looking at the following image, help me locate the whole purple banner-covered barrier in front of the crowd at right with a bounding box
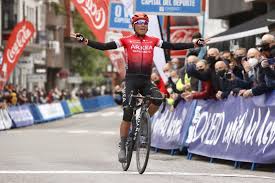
[151,93,275,169]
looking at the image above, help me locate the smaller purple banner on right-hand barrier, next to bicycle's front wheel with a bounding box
[151,102,195,149]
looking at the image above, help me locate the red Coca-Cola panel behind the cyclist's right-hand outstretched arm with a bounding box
[170,26,199,58]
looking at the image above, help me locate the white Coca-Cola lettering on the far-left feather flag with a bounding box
[7,26,32,63]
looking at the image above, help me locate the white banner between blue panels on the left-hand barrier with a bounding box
[37,103,65,121]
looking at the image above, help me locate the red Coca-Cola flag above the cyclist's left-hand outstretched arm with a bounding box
[72,0,110,42]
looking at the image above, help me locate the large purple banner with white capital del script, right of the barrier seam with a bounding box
[187,94,275,163]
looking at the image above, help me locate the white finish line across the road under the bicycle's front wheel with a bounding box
[0,170,275,180]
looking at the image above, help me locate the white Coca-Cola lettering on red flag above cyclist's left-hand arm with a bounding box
[76,0,107,30]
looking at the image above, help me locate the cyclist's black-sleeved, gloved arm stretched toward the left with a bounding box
[71,33,118,50]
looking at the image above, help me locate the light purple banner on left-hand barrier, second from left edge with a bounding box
[8,105,34,127]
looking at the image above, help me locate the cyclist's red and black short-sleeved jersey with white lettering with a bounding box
[116,35,163,76]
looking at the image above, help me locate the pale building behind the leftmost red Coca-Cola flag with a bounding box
[1,0,46,90]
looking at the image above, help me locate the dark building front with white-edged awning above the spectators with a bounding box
[209,0,275,50]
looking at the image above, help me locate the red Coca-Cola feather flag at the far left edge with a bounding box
[0,20,35,90]
